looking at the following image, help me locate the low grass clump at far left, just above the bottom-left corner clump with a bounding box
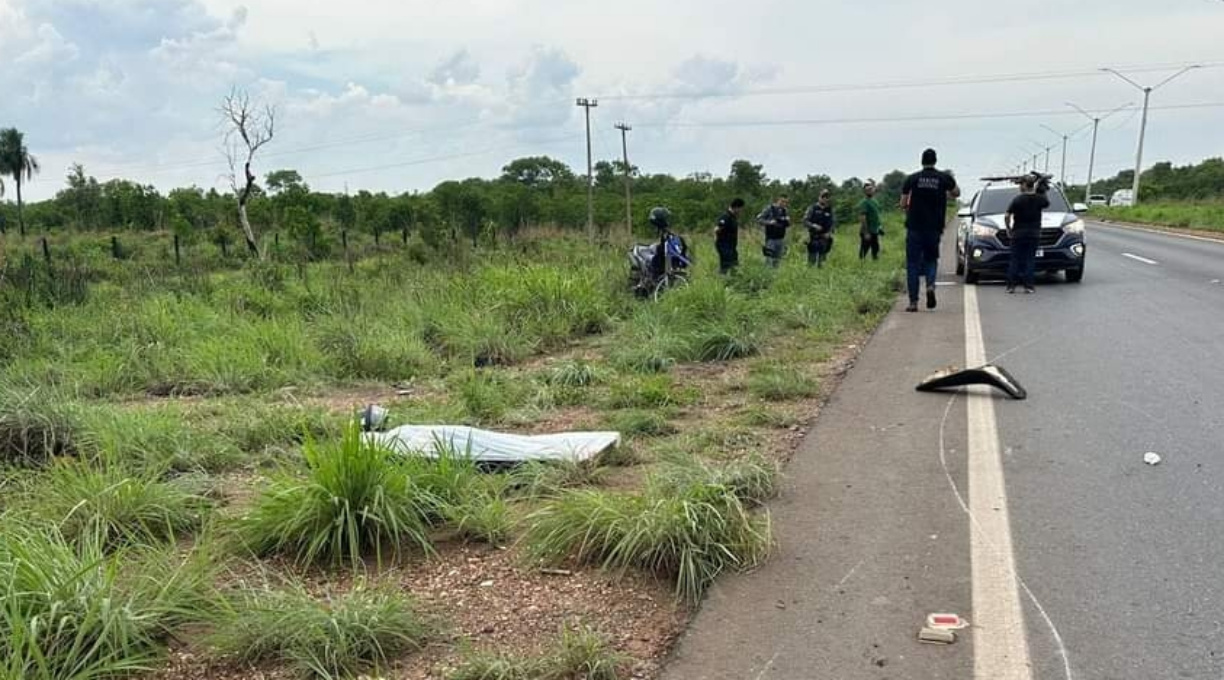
[24,461,208,545]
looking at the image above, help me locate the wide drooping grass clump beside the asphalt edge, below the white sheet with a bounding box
[525,482,770,603]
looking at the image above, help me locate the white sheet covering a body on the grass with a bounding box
[364,426,621,464]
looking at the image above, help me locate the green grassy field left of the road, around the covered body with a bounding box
[0,220,901,680]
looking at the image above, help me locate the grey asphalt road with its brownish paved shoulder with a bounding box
[665,225,1224,680]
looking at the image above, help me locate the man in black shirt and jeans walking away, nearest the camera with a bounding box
[901,149,961,312]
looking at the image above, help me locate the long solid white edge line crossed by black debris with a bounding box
[965,286,1033,680]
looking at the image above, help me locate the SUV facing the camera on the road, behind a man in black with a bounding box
[956,181,1088,284]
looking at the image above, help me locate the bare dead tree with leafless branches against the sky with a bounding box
[219,87,277,259]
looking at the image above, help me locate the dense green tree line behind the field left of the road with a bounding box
[0,151,920,249]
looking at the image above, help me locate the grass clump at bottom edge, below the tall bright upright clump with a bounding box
[212,585,437,680]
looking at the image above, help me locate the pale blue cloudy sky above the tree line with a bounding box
[0,0,1224,201]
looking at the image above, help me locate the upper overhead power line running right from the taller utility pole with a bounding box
[601,61,1224,100]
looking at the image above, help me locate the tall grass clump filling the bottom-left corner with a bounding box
[0,525,212,680]
